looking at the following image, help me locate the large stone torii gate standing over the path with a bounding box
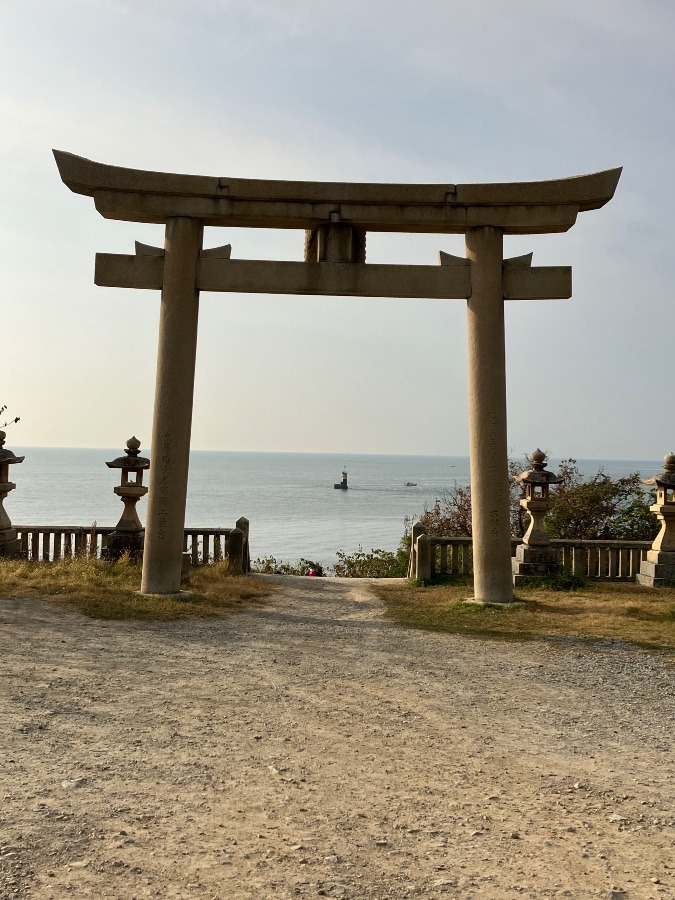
[54,150,621,603]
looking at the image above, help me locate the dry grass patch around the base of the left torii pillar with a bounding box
[0,557,277,622]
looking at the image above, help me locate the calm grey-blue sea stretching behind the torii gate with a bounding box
[5,445,661,566]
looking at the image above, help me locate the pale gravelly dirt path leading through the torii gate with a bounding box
[0,577,675,900]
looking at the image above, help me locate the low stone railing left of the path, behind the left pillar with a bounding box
[13,517,251,572]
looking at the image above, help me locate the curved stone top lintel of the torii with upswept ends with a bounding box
[54,150,621,234]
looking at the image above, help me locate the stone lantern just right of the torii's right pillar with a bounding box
[512,448,562,584]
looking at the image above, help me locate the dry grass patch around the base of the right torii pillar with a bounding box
[373,583,675,652]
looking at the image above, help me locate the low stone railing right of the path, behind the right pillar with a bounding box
[408,528,651,581]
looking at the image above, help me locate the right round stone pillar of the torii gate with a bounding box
[466,227,513,603]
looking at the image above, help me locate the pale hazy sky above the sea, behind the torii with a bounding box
[0,0,675,458]
